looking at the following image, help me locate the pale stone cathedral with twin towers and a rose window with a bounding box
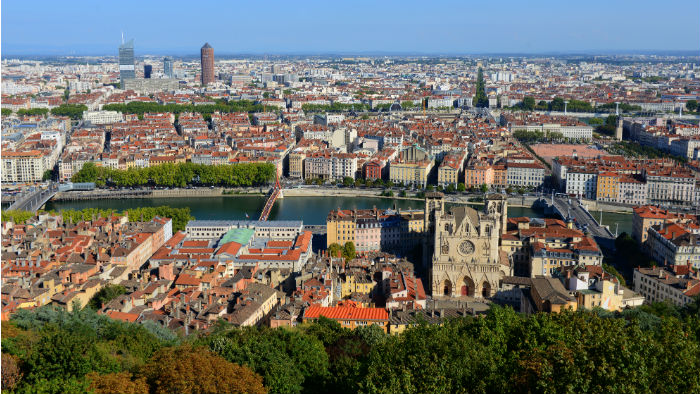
[425,193,512,299]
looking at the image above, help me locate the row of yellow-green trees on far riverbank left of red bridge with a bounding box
[71,162,276,187]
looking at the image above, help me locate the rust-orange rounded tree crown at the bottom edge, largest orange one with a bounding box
[141,345,267,394]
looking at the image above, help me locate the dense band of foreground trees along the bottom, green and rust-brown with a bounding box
[2,301,700,394]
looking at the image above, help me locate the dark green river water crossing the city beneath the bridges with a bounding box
[45,196,632,234]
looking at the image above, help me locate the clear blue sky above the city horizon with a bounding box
[0,0,700,56]
